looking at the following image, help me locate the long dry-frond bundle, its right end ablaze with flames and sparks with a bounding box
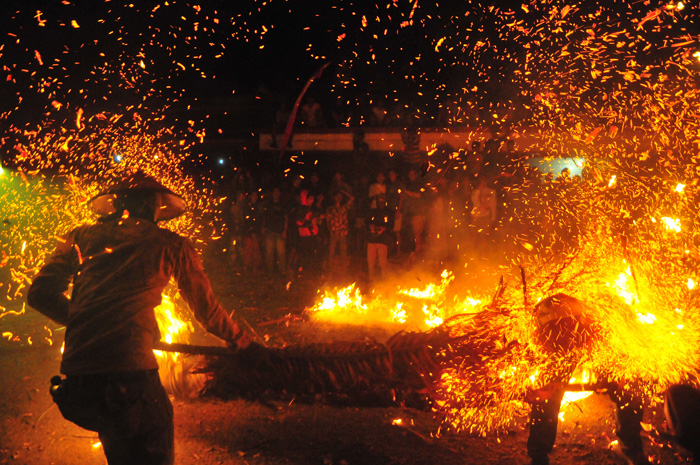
[187,238,698,433]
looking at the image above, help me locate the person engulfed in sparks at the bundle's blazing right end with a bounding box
[527,294,649,465]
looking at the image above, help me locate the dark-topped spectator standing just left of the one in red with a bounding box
[262,187,289,274]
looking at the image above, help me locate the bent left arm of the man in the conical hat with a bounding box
[27,234,77,325]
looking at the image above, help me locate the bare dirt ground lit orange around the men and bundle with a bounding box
[0,258,690,465]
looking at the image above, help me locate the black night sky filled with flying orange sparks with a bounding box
[0,0,700,161]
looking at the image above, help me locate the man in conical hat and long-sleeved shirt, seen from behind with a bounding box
[28,173,251,465]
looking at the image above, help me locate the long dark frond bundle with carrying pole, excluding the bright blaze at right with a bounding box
[152,296,604,418]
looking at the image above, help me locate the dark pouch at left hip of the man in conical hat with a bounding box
[49,376,107,431]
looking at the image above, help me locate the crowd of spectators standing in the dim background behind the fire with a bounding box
[223,136,579,283]
